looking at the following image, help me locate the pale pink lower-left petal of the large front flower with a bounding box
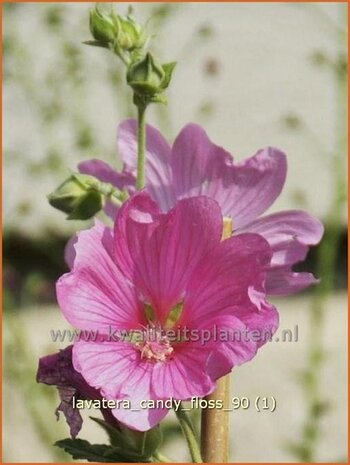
[73,342,168,431]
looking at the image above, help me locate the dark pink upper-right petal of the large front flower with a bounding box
[181,233,272,327]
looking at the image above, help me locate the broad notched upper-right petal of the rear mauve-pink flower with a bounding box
[171,124,287,229]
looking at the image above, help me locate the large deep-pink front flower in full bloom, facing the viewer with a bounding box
[57,192,278,430]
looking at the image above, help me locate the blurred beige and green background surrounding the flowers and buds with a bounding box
[3,2,347,463]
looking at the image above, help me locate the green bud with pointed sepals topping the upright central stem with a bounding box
[127,53,175,97]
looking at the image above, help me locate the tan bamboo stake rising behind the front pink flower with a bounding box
[201,218,233,463]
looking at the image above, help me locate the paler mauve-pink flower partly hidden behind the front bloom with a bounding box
[79,120,323,295]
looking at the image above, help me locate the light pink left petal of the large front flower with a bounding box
[56,222,145,333]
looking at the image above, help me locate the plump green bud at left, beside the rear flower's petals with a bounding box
[48,174,104,220]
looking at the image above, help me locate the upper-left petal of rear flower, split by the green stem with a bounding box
[117,119,175,211]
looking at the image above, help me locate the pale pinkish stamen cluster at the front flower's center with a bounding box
[136,328,174,362]
